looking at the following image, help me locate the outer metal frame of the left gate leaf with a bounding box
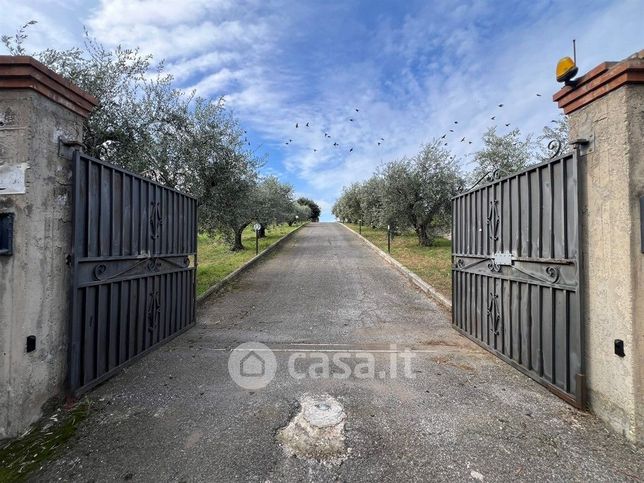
[64,149,199,398]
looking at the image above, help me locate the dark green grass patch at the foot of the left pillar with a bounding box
[0,400,90,482]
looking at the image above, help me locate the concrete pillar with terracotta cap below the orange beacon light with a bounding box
[553,51,644,442]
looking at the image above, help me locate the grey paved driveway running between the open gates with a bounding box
[35,224,644,481]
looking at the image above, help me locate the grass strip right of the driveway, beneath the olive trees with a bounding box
[345,223,452,298]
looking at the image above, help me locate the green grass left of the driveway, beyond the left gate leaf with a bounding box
[197,225,299,296]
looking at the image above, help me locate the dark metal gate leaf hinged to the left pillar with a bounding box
[68,151,197,394]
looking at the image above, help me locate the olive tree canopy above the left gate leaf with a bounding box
[1,21,320,250]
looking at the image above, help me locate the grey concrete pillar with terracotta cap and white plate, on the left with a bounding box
[0,56,96,439]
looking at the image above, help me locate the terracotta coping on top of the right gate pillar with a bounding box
[552,50,644,114]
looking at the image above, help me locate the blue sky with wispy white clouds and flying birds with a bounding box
[0,0,644,220]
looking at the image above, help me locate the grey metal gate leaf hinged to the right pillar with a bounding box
[452,153,585,407]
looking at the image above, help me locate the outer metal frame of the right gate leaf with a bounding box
[451,147,588,411]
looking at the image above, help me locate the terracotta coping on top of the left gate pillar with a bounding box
[0,55,98,118]
